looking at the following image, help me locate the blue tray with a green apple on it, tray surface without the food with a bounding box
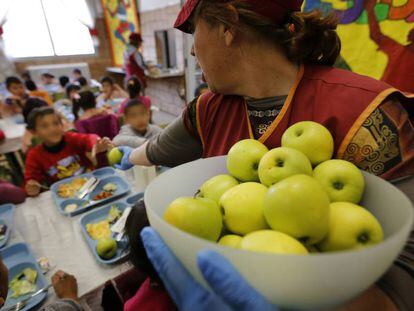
[79,192,144,265]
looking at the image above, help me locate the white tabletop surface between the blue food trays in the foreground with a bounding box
[8,169,149,310]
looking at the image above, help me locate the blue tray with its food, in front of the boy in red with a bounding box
[51,167,130,216]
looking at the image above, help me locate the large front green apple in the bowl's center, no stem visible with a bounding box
[264,175,329,245]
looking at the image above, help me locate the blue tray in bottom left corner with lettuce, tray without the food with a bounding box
[0,243,48,311]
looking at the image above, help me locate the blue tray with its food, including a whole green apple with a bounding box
[79,193,144,264]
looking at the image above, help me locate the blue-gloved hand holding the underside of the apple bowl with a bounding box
[141,227,278,311]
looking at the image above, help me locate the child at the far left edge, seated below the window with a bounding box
[0,77,29,118]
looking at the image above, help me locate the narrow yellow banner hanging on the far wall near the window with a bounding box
[101,0,140,66]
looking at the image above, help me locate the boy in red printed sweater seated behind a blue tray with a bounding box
[25,107,107,196]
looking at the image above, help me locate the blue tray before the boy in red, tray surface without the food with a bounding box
[50,167,130,217]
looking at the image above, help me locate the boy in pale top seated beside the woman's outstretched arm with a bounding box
[113,99,162,148]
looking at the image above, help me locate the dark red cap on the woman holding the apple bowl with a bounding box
[174,0,304,33]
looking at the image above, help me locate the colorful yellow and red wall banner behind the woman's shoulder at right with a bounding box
[304,0,414,87]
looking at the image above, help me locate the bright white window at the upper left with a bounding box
[1,0,95,58]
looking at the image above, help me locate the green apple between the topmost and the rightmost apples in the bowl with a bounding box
[313,160,365,203]
